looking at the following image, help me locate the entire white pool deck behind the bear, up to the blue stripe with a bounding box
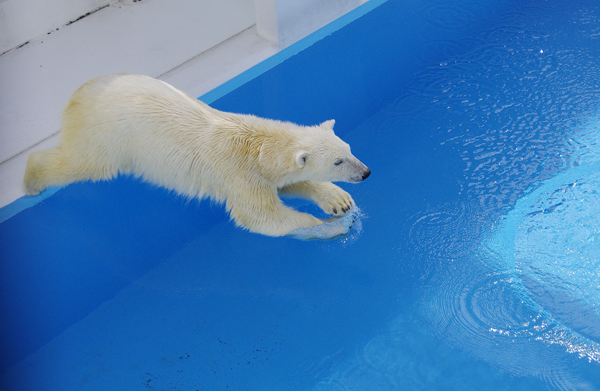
[0,0,365,207]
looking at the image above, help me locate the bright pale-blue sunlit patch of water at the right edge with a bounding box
[490,124,600,361]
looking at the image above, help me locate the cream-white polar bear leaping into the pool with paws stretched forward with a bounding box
[24,74,371,236]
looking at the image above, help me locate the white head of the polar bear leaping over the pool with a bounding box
[294,120,371,183]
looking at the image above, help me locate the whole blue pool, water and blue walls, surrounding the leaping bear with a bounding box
[0,0,600,391]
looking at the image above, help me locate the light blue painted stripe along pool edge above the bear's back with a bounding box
[198,0,387,104]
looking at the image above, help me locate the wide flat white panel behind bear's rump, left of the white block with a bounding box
[0,0,255,162]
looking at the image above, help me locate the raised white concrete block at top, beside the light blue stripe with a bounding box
[254,0,366,49]
